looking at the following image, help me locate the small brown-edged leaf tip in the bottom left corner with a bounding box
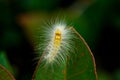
[0,64,15,80]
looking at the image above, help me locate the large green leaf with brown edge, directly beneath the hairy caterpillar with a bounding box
[32,28,97,80]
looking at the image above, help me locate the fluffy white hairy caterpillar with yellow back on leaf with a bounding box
[38,22,75,65]
